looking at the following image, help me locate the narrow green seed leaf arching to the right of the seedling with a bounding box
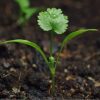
[61,29,97,48]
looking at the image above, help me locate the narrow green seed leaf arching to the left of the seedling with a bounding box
[0,39,49,65]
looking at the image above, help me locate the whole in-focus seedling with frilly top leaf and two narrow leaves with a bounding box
[0,8,97,95]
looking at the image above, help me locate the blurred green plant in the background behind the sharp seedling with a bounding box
[15,0,38,25]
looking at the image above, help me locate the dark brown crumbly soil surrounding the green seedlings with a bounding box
[0,0,100,100]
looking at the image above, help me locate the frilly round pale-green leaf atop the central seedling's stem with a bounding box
[38,8,68,34]
